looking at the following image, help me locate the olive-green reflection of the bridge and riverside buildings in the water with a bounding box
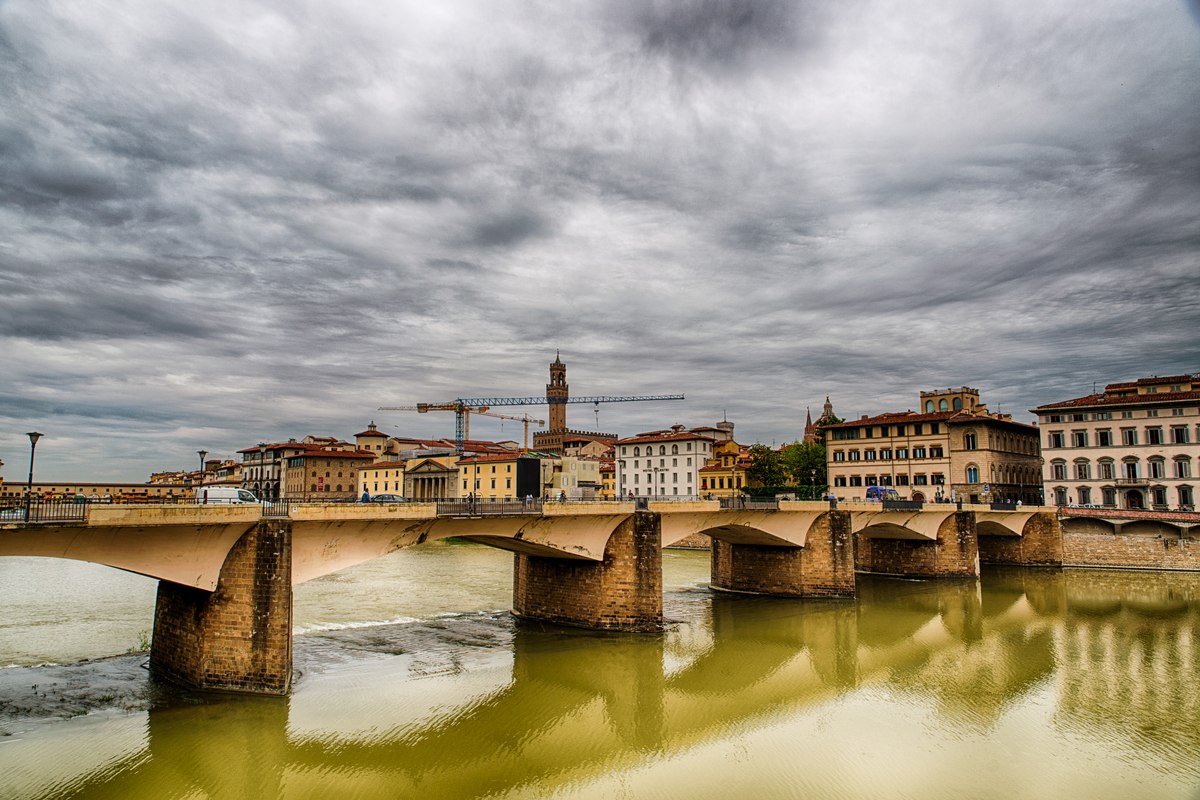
[42,570,1200,798]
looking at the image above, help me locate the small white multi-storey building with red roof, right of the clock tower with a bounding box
[616,425,713,498]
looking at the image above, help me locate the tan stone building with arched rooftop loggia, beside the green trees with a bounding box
[823,386,1042,505]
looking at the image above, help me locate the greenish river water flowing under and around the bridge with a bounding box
[0,542,1200,800]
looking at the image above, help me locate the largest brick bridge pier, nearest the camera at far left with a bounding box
[150,521,292,694]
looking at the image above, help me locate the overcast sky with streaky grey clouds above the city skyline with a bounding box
[0,0,1200,482]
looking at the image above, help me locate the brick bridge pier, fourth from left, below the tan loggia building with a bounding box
[857,511,979,578]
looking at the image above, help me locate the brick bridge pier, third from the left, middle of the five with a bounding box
[710,511,854,597]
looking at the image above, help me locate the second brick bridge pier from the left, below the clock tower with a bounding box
[512,511,662,631]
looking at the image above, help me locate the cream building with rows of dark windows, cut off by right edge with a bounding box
[1033,374,1200,510]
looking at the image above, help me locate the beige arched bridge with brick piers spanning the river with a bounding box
[0,501,1061,693]
